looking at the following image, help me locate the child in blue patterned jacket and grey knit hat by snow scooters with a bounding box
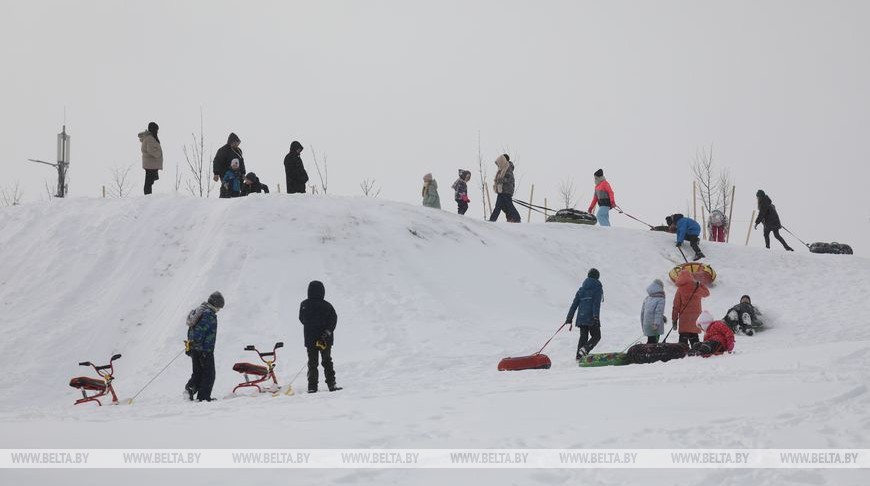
[184,292,225,402]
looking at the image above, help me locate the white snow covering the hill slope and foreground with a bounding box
[0,195,870,485]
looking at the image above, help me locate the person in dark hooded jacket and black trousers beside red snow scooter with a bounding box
[299,280,341,393]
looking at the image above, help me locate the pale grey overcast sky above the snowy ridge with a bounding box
[0,0,870,255]
